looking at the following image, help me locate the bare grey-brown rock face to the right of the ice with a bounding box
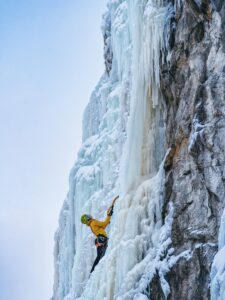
[156,0,225,300]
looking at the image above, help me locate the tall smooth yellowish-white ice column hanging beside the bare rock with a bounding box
[120,0,166,195]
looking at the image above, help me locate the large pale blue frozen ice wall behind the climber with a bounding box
[53,0,170,300]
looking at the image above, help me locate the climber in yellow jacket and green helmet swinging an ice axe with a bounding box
[81,196,119,273]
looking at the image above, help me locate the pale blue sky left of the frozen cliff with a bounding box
[0,0,106,300]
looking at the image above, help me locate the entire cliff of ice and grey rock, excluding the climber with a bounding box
[53,0,225,300]
